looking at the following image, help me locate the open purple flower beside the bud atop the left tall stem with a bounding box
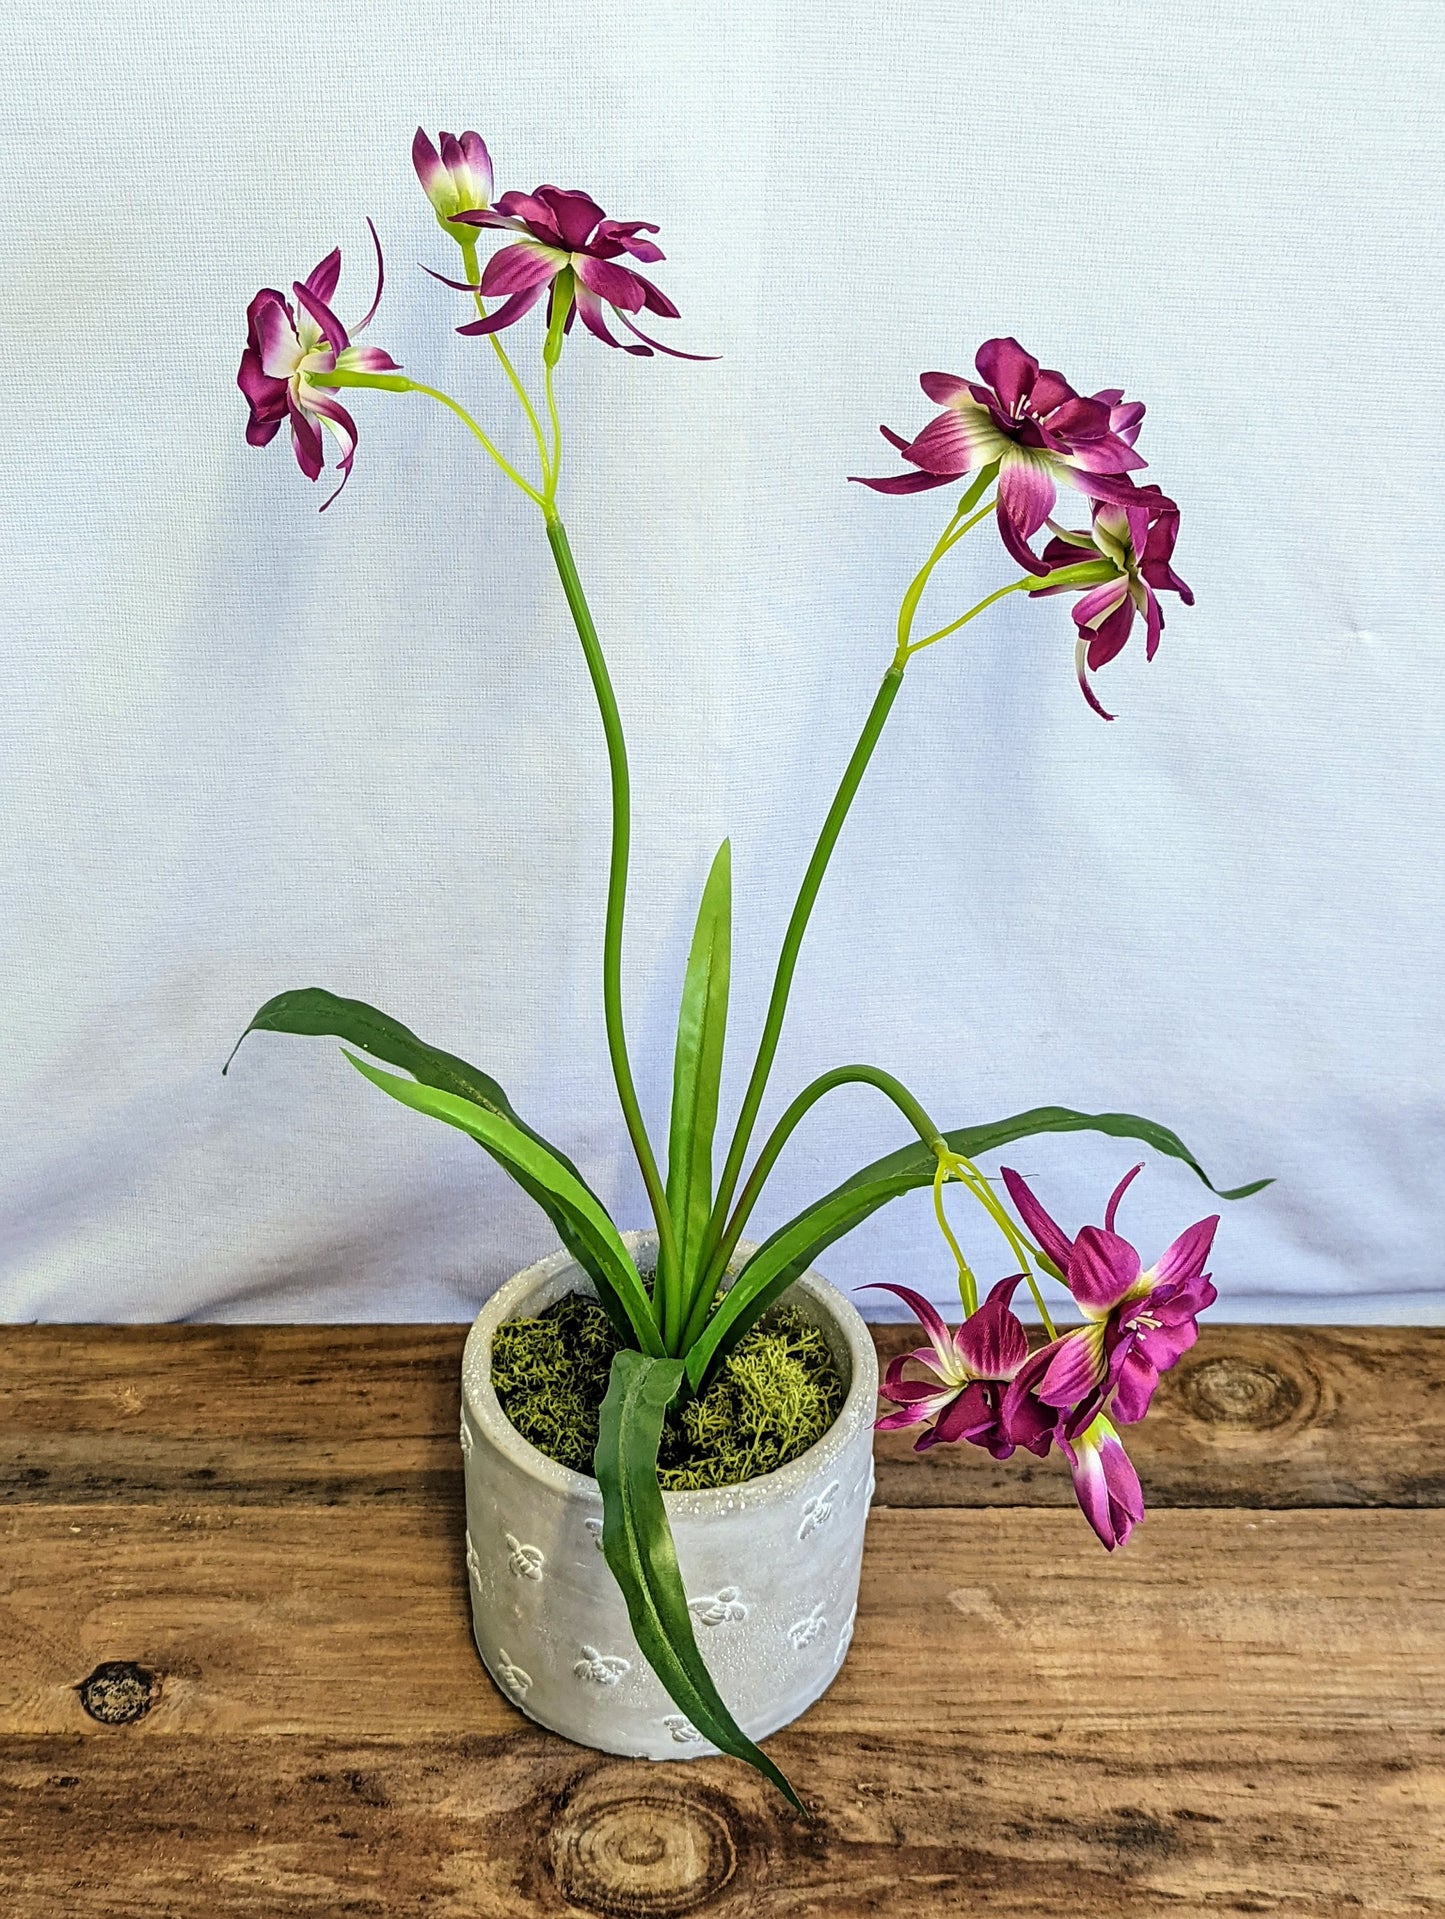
[434,186,708,359]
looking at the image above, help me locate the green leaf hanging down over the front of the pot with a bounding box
[595,1353,808,1817]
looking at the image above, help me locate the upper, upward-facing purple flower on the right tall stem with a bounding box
[852,340,1148,574]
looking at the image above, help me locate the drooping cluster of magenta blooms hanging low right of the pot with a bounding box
[877,1167,1219,1551]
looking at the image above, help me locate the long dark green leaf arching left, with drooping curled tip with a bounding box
[221,986,629,1339]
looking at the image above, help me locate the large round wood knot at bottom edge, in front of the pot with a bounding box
[551,1794,737,1919]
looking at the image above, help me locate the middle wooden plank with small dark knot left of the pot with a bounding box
[0,1504,1445,1752]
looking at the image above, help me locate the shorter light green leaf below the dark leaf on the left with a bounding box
[342,1048,662,1355]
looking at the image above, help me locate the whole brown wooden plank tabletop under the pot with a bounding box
[0,1326,1445,1919]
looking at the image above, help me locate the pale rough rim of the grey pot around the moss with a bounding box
[462,1232,879,1522]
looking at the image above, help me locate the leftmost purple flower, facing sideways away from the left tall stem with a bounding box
[236,221,397,512]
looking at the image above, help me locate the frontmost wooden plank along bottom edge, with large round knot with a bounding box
[0,1723,1445,1919]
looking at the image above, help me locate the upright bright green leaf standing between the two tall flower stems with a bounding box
[668,841,733,1290]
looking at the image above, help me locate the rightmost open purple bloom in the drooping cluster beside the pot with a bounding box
[1002,1167,1219,1447]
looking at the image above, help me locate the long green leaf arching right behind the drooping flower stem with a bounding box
[687,1105,1270,1389]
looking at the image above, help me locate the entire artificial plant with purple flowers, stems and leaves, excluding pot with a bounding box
[228,129,1267,1798]
